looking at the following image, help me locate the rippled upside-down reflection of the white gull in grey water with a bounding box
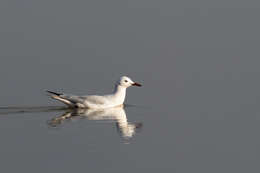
[48,107,142,139]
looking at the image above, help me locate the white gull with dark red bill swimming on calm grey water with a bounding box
[47,76,142,109]
